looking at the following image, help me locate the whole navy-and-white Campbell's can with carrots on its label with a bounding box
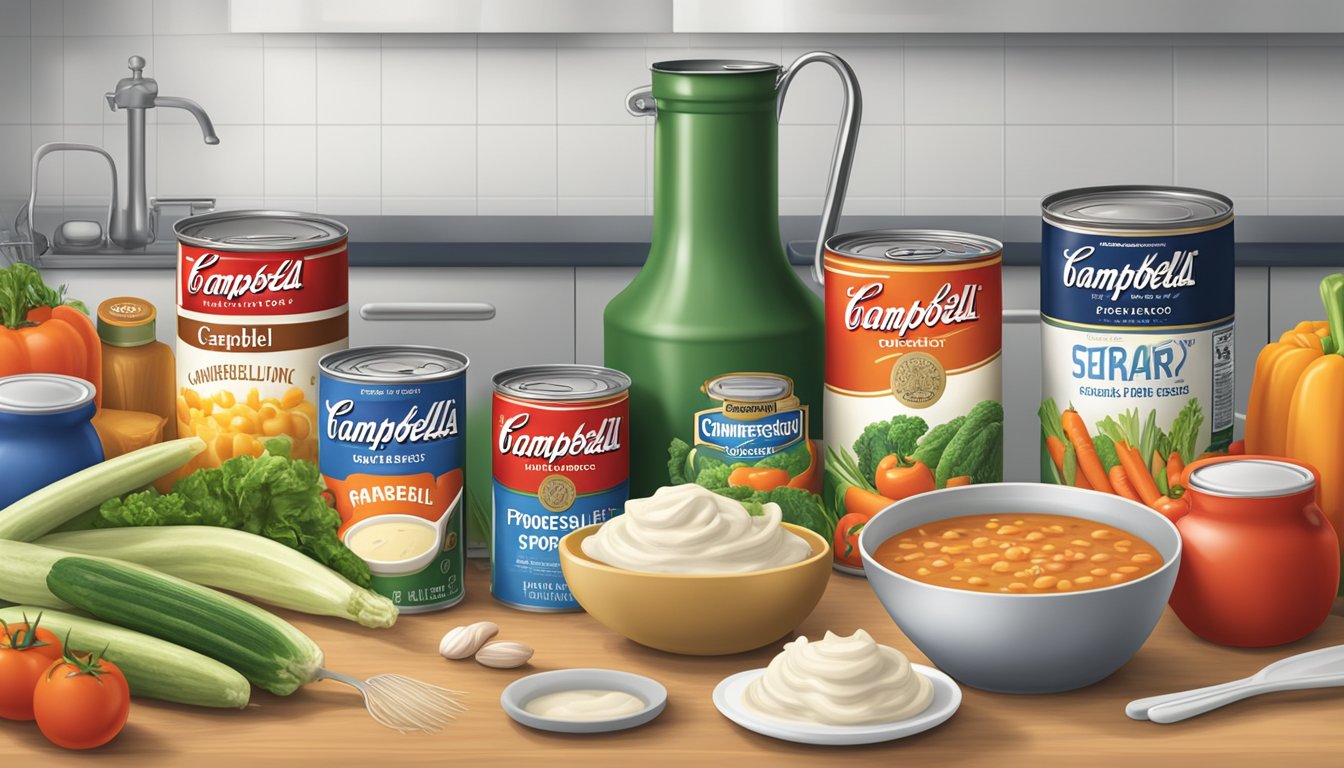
[1040,187,1235,492]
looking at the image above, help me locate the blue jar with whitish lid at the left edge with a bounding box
[0,374,102,508]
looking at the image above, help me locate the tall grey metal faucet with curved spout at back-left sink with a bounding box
[106,56,219,249]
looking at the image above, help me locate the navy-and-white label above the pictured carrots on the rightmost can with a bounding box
[1040,222,1235,482]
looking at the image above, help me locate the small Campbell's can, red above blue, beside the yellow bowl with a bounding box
[491,364,630,611]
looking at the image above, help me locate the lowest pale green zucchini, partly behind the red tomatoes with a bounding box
[0,605,251,709]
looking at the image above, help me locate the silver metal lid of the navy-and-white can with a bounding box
[1040,186,1232,231]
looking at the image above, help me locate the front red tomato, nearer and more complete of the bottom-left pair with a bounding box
[32,654,130,749]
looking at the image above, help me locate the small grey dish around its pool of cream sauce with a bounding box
[500,668,668,733]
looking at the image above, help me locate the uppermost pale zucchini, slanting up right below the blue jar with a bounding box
[0,437,206,541]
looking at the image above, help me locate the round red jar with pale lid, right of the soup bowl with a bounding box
[1171,456,1340,647]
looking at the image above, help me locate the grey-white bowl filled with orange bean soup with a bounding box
[859,483,1181,693]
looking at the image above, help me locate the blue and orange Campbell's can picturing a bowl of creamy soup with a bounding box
[320,346,468,613]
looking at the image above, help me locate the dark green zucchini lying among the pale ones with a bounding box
[46,554,323,695]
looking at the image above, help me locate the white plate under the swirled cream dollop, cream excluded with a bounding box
[714,664,961,746]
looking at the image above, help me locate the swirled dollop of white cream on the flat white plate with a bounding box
[743,629,933,725]
